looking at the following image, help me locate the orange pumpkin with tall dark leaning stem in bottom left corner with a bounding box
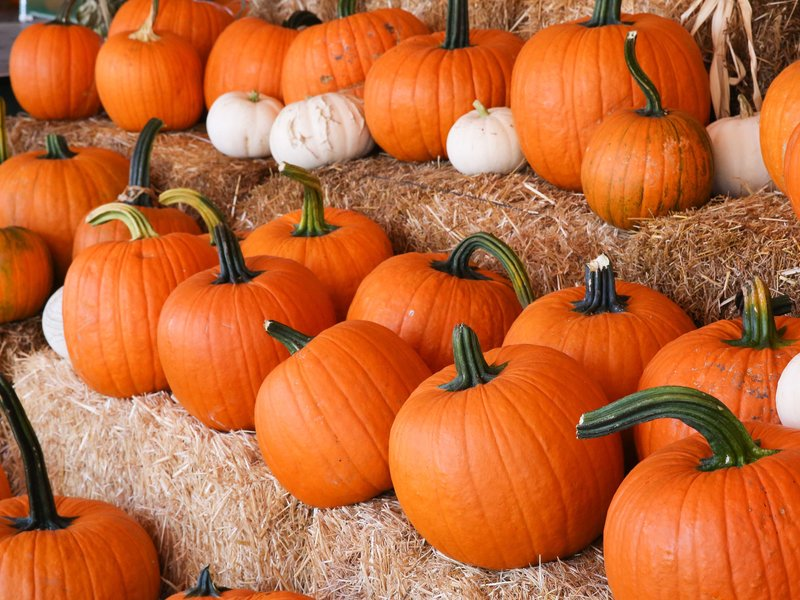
[0,377,161,600]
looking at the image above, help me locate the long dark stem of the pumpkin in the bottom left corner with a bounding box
[0,376,75,531]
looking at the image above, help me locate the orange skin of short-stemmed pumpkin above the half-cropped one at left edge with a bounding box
[0,136,128,281]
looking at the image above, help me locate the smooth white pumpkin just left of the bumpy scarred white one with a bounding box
[206,92,283,158]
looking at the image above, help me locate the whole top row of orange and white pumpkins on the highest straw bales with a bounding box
[10,0,800,228]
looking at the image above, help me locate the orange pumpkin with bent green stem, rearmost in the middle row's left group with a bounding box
[242,163,392,320]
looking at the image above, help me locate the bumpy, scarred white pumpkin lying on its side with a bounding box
[269,93,375,169]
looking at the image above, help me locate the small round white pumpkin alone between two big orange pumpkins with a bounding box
[447,100,525,175]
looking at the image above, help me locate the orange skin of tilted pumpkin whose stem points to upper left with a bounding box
[256,321,431,508]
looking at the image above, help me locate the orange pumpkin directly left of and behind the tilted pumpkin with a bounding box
[158,225,336,431]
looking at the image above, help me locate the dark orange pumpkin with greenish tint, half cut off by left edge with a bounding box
[0,227,53,324]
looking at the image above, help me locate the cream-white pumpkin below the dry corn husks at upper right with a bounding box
[706,95,770,198]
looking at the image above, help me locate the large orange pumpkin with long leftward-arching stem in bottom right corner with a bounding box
[578,387,800,600]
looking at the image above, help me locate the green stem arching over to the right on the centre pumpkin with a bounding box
[431,231,533,308]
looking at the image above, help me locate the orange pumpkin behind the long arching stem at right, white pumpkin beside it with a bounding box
[634,278,800,458]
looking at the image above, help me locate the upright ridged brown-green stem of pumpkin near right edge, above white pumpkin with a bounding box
[725,277,796,350]
